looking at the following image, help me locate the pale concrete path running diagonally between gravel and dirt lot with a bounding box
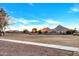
[0,39,79,52]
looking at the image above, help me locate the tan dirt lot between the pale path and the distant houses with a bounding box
[0,33,79,47]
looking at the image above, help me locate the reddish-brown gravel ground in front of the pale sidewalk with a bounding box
[0,41,79,56]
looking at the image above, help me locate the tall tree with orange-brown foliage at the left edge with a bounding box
[0,8,9,35]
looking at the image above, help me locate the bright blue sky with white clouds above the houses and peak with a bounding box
[0,3,79,31]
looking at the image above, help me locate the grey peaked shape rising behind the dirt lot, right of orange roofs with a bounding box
[50,25,69,34]
